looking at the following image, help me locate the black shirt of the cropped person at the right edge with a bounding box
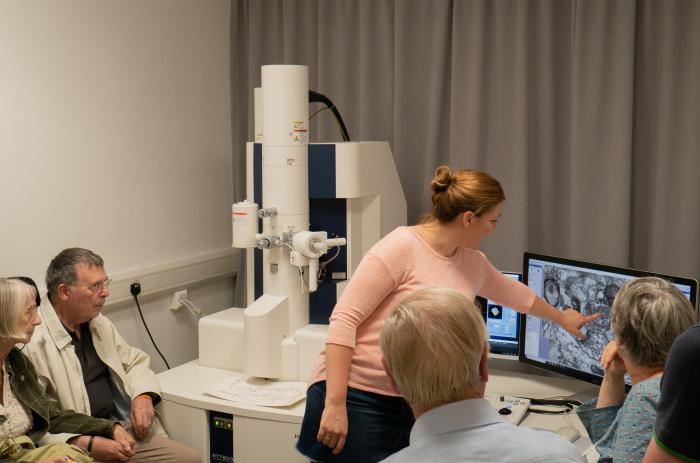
[654,324,700,461]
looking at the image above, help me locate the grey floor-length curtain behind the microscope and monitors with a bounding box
[231,0,700,278]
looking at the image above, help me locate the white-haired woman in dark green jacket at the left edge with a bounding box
[0,278,133,463]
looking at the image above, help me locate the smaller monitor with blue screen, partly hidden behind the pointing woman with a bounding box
[477,272,522,357]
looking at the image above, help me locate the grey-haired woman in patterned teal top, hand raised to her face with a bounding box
[577,277,695,463]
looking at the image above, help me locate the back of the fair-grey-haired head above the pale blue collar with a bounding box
[380,289,487,408]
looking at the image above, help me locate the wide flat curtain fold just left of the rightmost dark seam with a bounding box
[562,0,635,263]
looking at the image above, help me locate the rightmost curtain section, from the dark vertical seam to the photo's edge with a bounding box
[630,0,700,279]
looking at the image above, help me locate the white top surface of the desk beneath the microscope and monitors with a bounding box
[158,358,597,452]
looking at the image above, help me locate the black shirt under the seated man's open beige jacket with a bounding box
[66,322,114,418]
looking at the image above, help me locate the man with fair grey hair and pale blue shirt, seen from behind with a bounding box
[380,289,584,463]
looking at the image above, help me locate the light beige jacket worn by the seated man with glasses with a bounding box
[24,300,165,435]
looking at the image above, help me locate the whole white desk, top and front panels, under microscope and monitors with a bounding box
[158,358,598,463]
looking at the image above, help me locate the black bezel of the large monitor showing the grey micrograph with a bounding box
[518,252,698,385]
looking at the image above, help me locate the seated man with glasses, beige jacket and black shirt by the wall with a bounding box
[25,248,199,463]
